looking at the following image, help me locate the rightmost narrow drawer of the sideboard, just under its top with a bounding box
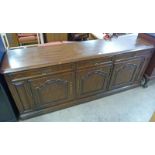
[114,50,152,61]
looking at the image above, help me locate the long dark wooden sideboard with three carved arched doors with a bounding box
[1,35,154,119]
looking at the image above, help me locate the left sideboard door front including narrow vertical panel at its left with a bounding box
[13,72,74,113]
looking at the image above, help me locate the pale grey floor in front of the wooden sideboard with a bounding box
[25,81,155,122]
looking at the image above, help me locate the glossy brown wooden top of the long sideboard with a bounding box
[1,35,154,74]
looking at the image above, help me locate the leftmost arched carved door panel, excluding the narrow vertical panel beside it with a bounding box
[28,72,74,107]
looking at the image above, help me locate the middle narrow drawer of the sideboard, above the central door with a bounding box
[77,57,112,69]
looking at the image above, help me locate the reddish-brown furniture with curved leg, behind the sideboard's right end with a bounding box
[139,33,155,88]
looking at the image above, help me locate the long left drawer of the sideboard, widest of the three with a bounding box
[9,63,74,81]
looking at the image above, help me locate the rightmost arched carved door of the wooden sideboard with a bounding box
[110,57,145,89]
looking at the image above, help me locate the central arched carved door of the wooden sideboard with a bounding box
[77,64,112,97]
